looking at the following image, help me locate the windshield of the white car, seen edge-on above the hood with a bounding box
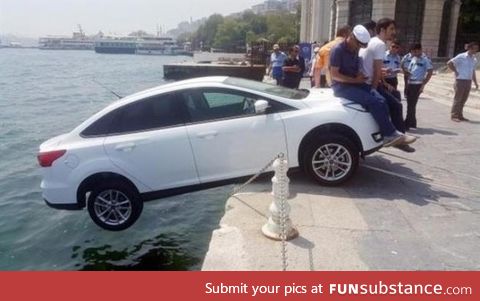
[224,77,310,99]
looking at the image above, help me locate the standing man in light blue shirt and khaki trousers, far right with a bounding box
[447,42,478,122]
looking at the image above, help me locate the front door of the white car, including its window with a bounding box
[179,88,287,183]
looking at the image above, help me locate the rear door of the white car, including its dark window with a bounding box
[104,94,199,191]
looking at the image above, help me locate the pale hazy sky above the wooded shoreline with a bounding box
[0,0,263,38]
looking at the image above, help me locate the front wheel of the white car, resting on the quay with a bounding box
[303,134,359,186]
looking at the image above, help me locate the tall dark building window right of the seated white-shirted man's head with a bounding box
[395,0,425,49]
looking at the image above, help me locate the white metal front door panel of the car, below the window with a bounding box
[187,114,287,183]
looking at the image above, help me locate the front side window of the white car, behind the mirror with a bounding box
[183,88,257,122]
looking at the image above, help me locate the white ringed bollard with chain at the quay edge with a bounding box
[262,154,298,240]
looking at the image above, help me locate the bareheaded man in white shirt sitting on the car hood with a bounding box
[359,18,416,152]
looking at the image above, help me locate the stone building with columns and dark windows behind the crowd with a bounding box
[300,0,462,58]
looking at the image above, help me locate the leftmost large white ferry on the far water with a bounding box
[38,25,94,50]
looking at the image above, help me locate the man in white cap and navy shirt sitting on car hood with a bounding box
[330,25,407,146]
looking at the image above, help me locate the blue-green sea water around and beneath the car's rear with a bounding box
[0,49,232,270]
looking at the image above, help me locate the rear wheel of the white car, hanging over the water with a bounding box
[87,181,143,231]
